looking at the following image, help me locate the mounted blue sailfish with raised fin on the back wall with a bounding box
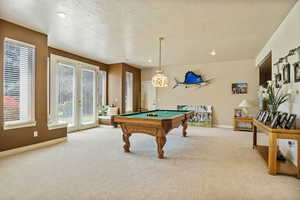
[173,71,211,89]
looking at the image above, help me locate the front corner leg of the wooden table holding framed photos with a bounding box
[268,133,277,175]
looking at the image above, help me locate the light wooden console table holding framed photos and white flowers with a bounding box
[253,119,300,179]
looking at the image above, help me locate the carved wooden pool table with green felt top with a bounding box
[113,110,194,159]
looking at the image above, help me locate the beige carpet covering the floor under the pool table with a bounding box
[0,127,300,200]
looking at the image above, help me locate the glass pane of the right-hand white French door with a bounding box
[80,69,96,125]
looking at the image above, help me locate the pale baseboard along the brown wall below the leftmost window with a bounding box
[0,137,67,158]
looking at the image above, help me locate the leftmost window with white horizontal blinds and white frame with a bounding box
[3,38,35,126]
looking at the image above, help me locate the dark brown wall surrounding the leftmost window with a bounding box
[0,19,67,151]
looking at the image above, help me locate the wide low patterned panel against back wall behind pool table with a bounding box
[177,105,213,127]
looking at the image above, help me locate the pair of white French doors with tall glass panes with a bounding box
[51,56,98,131]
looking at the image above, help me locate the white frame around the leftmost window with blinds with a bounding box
[2,37,36,130]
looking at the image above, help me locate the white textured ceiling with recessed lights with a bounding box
[0,0,297,67]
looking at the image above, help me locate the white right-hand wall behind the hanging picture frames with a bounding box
[256,1,300,166]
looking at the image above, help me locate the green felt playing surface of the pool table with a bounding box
[120,110,189,119]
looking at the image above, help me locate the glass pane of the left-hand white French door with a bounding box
[56,64,75,127]
